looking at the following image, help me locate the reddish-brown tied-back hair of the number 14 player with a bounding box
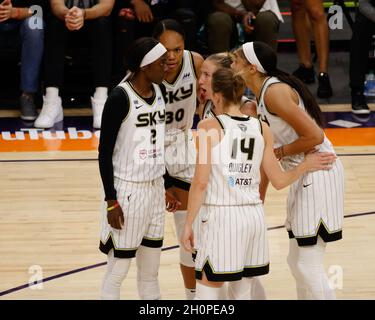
[211,68,246,104]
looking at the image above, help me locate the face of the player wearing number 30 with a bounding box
[159,30,185,73]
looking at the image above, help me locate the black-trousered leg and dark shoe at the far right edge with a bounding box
[350,0,375,114]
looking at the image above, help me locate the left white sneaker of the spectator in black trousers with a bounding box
[34,96,64,128]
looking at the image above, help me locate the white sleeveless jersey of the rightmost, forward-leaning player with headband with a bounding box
[257,77,335,170]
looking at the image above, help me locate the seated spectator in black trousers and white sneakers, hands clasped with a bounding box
[34,0,115,128]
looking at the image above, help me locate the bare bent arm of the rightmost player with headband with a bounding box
[264,83,324,158]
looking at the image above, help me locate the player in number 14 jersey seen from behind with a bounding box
[181,69,335,300]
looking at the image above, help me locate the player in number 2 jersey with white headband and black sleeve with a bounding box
[99,38,166,299]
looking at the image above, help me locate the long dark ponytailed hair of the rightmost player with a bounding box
[241,41,322,127]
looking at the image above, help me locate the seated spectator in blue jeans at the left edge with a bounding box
[0,0,44,120]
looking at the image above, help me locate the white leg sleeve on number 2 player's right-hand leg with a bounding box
[136,246,161,300]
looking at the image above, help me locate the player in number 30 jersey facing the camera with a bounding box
[153,19,203,300]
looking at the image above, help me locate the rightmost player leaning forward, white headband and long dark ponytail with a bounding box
[233,42,344,299]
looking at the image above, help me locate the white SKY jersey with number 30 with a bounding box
[163,50,197,141]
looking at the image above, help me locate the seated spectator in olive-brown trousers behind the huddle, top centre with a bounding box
[207,0,283,54]
